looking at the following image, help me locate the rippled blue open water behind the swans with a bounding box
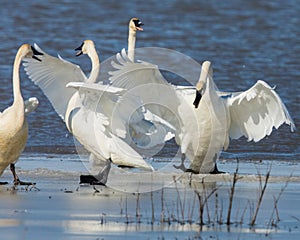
[0,0,300,160]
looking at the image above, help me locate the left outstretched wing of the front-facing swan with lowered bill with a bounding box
[109,49,180,128]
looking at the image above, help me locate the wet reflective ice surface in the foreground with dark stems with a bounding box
[0,154,300,239]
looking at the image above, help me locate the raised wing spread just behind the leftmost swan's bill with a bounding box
[23,44,86,119]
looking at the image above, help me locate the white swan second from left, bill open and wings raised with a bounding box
[23,40,153,184]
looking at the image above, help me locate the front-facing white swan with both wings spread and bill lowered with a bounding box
[109,50,295,173]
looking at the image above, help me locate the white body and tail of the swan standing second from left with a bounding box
[67,82,153,170]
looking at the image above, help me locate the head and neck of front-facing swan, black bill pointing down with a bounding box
[193,61,212,108]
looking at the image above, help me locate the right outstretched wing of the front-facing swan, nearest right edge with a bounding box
[227,80,295,142]
